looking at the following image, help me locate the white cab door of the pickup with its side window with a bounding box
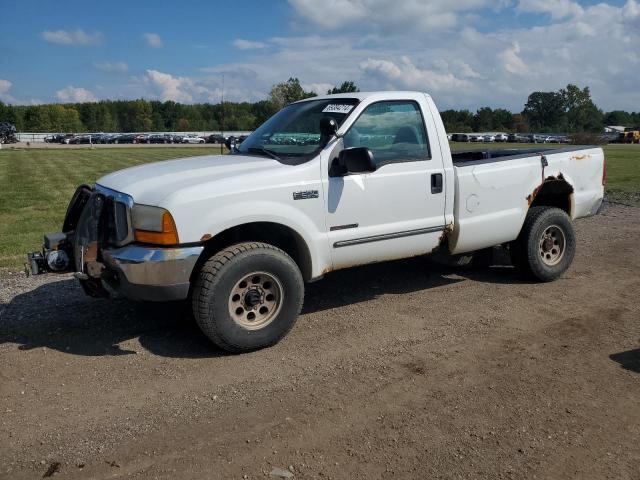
[325,100,445,269]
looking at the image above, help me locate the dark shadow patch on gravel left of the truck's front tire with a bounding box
[0,279,224,358]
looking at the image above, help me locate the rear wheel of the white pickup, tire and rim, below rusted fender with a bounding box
[509,207,576,282]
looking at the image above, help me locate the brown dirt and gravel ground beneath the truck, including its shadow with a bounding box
[0,205,640,479]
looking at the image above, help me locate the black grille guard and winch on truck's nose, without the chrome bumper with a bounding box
[27,185,133,297]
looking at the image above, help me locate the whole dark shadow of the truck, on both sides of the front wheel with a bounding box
[0,259,522,358]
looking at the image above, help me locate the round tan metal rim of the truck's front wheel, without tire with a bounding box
[229,272,284,330]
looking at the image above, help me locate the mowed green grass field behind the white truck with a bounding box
[0,144,640,271]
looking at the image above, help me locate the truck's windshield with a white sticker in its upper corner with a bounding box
[238,98,358,164]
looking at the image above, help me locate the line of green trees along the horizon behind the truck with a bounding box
[0,78,640,133]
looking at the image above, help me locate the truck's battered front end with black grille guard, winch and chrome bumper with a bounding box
[27,184,204,302]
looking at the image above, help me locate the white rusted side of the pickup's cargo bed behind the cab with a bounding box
[449,146,604,253]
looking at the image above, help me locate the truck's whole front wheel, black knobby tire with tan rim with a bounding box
[192,242,304,353]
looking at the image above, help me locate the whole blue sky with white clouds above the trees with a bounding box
[0,0,640,111]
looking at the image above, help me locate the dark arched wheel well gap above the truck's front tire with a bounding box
[191,222,312,281]
